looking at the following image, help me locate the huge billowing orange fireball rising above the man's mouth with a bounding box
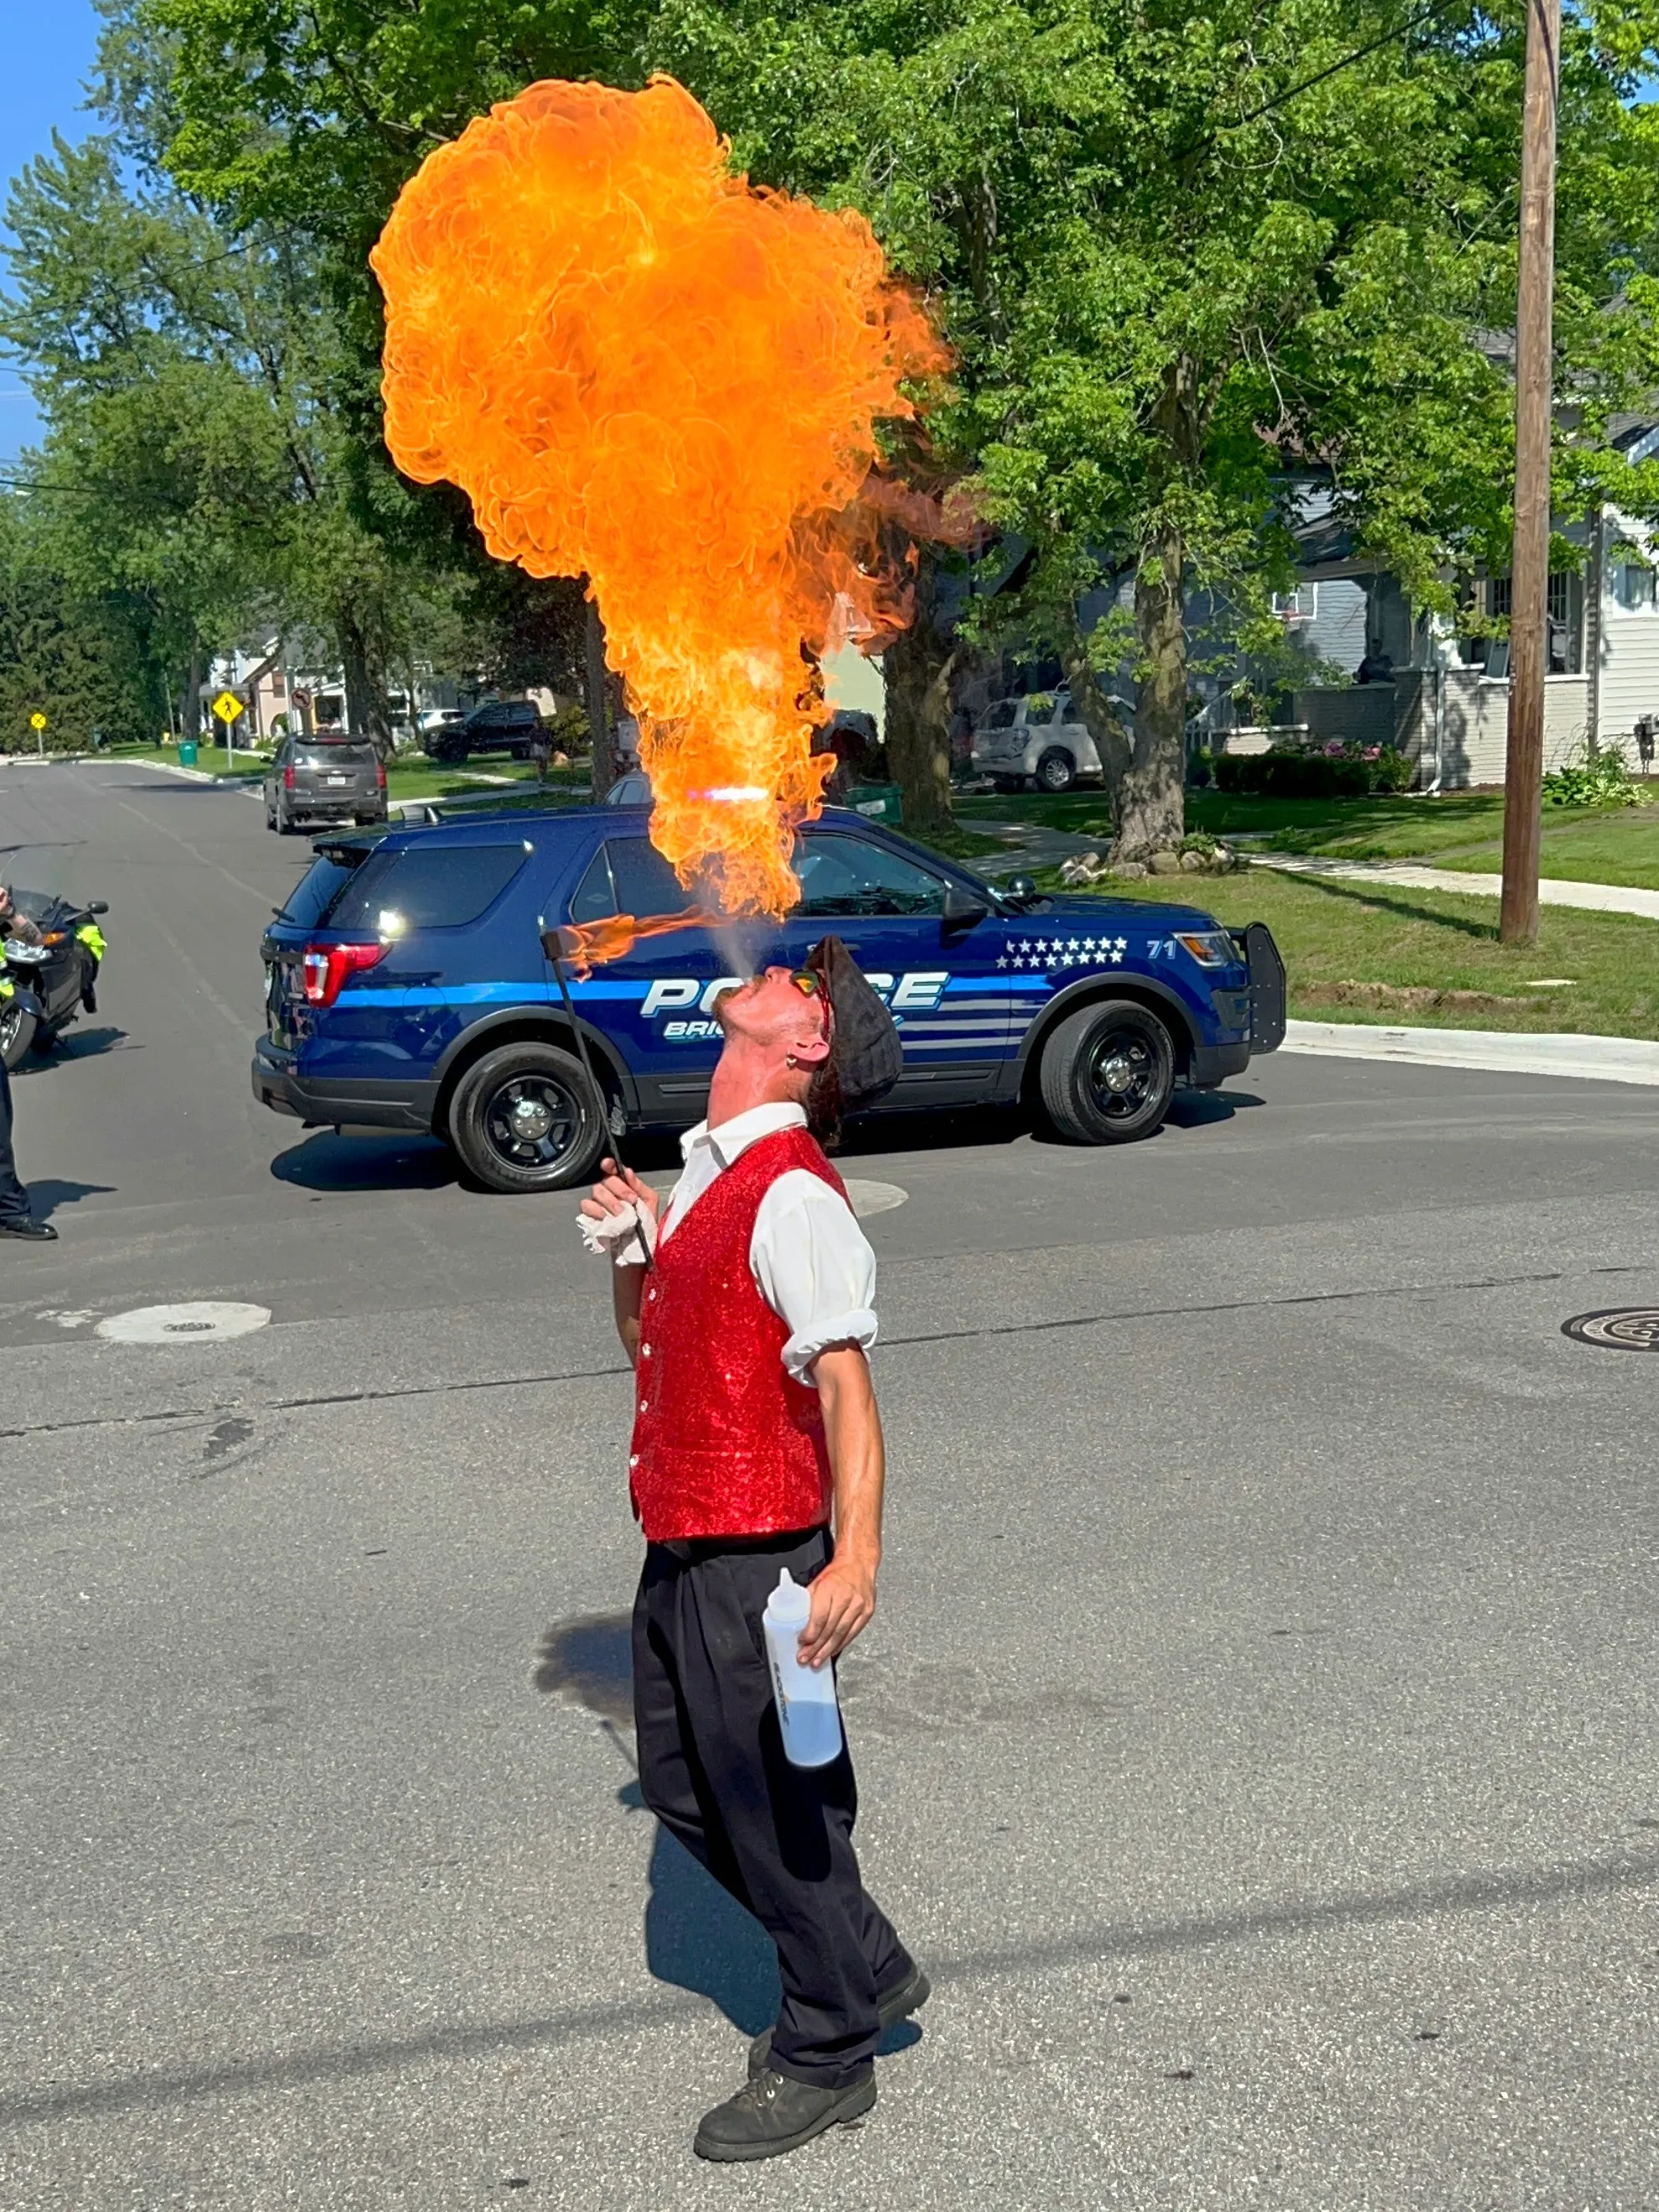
[372,77,947,913]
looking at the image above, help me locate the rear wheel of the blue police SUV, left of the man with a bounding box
[449,1044,606,1190]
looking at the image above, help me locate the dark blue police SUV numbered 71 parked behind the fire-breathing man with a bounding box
[252,805,1285,1190]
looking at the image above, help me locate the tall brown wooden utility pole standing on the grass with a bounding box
[1497,0,1562,944]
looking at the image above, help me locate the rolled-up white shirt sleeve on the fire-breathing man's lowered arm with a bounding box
[750,1168,876,1382]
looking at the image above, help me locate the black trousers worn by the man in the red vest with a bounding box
[633,1528,912,2088]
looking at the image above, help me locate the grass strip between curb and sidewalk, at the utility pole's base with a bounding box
[1040,870,1659,1037]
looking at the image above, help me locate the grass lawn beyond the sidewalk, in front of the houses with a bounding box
[955,781,1659,892]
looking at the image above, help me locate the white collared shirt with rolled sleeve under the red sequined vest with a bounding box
[657,1103,876,1382]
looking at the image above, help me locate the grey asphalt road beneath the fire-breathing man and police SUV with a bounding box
[0,765,1659,2212]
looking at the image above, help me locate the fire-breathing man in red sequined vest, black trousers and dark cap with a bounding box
[581,938,929,2161]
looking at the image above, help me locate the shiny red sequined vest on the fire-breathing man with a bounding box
[628,1128,847,1544]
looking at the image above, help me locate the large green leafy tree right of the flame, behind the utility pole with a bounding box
[653,0,1659,856]
